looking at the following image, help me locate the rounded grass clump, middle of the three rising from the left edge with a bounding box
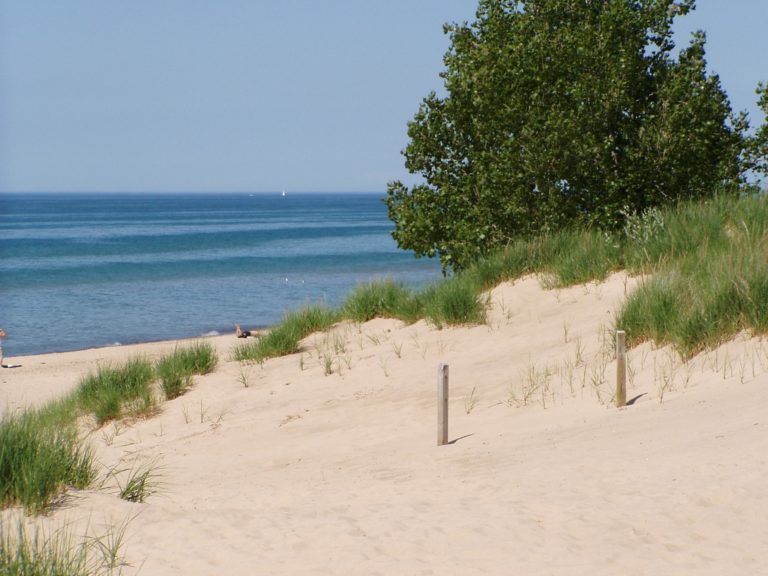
[77,357,156,425]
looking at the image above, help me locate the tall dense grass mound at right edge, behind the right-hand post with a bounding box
[616,197,768,356]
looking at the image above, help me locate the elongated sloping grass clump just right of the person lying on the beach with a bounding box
[232,306,341,362]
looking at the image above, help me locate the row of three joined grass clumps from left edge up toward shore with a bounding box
[0,342,218,512]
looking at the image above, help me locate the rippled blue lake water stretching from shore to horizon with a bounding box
[0,193,440,357]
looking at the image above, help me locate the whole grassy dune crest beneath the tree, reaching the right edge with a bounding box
[465,195,768,356]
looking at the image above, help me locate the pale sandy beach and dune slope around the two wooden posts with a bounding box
[0,274,768,576]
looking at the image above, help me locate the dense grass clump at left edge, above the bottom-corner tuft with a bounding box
[0,411,96,512]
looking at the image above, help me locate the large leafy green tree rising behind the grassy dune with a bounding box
[386,0,767,269]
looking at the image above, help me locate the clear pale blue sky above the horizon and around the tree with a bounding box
[0,0,768,192]
